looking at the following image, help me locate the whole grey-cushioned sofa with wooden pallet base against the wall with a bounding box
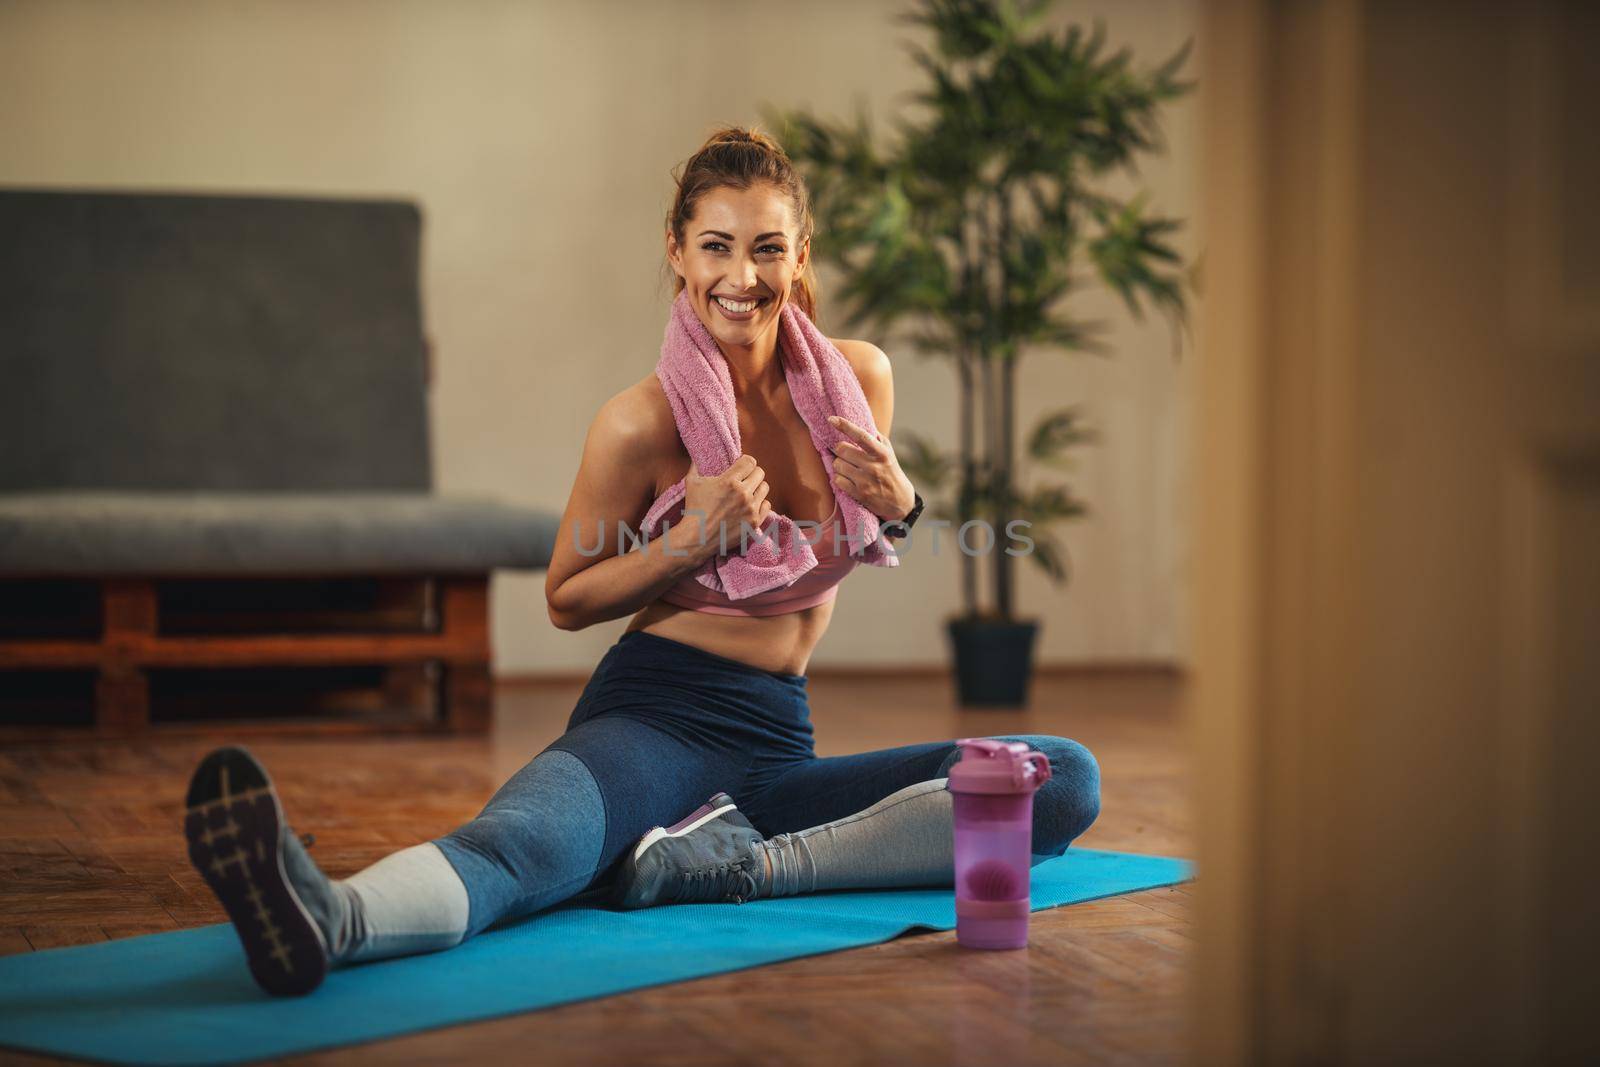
[0,189,558,731]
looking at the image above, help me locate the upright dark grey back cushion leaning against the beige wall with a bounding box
[0,189,432,491]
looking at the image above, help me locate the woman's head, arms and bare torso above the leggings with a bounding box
[546,128,915,673]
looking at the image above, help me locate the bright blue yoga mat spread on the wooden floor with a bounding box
[0,849,1190,1064]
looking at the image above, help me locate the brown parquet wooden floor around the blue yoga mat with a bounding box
[0,662,1194,1067]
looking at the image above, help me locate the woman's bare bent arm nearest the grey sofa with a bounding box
[544,390,717,630]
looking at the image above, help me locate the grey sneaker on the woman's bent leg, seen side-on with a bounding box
[611,793,766,910]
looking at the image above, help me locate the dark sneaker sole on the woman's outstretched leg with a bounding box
[184,747,328,997]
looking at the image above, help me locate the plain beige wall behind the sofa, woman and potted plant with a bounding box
[0,0,1195,672]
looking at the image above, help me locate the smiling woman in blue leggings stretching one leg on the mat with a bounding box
[186,128,1099,993]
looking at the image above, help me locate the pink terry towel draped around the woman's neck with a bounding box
[642,290,899,600]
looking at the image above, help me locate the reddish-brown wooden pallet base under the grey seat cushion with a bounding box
[0,574,493,739]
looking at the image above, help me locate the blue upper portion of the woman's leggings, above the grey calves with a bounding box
[434,630,1099,936]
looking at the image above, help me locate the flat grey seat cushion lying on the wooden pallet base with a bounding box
[0,491,560,576]
